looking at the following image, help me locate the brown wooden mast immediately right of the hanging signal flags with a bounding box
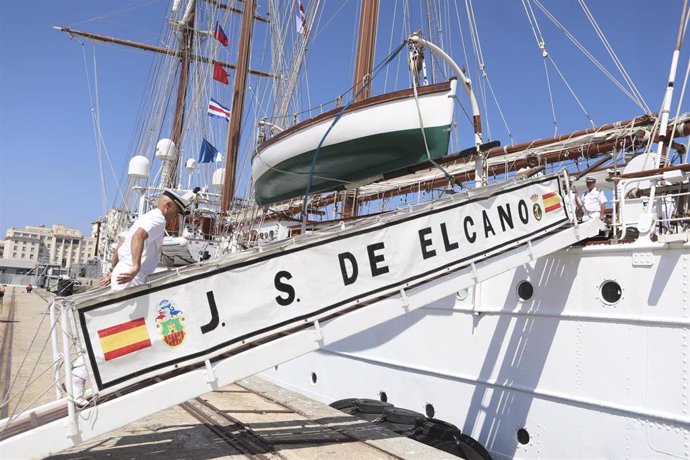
[220,0,255,212]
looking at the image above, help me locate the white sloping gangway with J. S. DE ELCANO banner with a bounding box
[0,173,603,458]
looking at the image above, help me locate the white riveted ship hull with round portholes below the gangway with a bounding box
[264,239,690,458]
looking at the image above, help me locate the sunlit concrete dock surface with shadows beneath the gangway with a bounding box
[0,286,457,459]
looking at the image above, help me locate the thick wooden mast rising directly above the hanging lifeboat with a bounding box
[352,0,379,101]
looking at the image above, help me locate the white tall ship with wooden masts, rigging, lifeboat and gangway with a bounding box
[0,0,690,458]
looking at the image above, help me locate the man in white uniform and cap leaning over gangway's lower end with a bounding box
[100,190,194,291]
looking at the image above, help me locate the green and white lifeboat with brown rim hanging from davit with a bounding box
[252,78,457,205]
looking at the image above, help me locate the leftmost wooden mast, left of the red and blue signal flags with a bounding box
[167,5,196,188]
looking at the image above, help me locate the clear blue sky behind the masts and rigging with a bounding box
[0,0,688,241]
